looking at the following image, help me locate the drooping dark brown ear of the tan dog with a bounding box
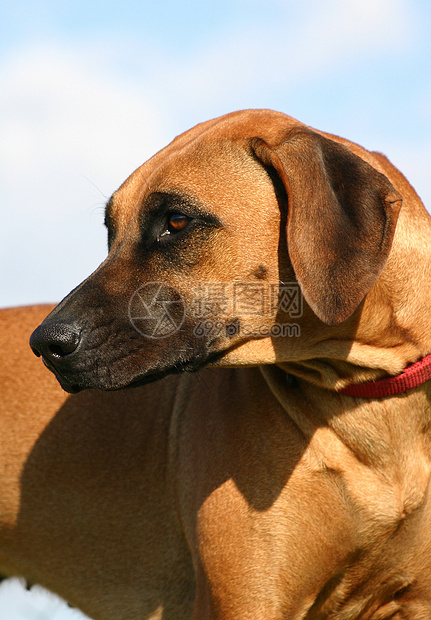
[251,128,402,325]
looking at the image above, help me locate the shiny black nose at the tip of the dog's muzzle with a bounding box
[30,321,80,362]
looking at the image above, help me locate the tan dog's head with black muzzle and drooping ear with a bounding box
[31,110,401,391]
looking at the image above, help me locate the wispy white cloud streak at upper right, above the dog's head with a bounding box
[152,0,414,107]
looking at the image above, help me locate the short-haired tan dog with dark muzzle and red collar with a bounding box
[2,111,431,620]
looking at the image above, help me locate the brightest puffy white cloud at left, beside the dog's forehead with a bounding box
[0,46,164,199]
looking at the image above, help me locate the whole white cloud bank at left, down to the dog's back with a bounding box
[0,46,167,305]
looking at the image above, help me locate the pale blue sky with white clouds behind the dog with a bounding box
[0,0,431,620]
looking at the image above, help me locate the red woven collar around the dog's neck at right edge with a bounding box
[339,353,431,398]
